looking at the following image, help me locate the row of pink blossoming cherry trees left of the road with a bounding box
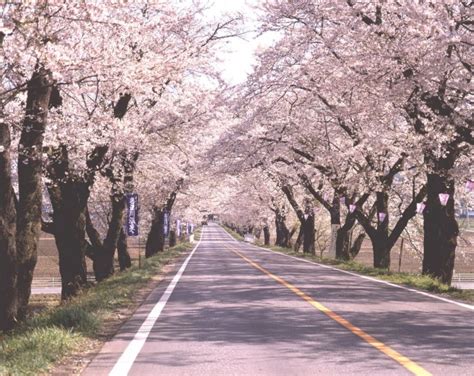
[0,1,238,330]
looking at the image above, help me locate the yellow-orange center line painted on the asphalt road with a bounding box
[228,248,431,376]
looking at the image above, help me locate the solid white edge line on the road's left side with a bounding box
[109,229,204,376]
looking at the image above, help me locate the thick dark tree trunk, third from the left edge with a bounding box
[49,181,89,300]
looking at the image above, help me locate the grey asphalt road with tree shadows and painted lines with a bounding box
[84,224,474,376]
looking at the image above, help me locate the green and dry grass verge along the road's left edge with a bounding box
[0,243,191,375]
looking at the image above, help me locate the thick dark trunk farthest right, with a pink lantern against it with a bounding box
[423,174,459,284]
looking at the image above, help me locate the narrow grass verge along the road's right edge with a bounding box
[224,227,474,303]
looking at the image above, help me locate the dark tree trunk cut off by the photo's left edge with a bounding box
[0,123,17,331]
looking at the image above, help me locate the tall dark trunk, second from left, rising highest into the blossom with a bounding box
[16,68,52,318]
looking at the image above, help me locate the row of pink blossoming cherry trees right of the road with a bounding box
[214,0,474,283]
